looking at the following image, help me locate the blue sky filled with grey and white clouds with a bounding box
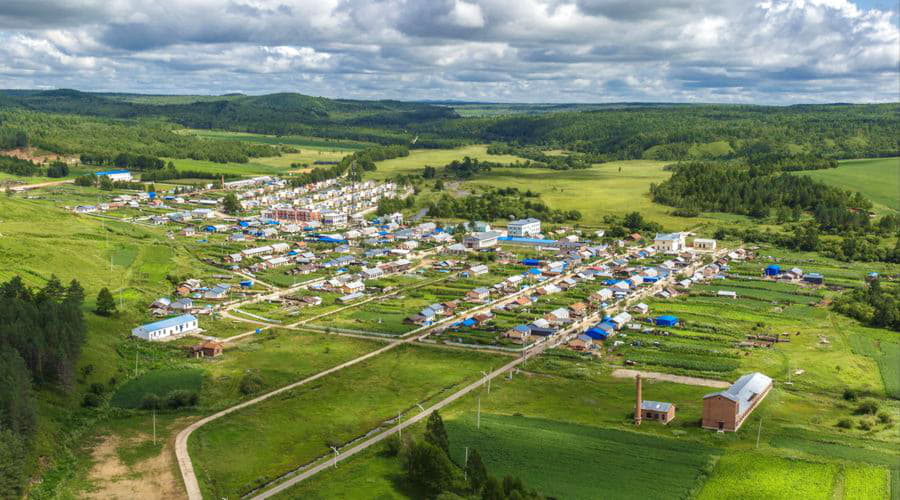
[0,0,900,104]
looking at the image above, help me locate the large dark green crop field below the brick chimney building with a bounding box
[447,413,715,500]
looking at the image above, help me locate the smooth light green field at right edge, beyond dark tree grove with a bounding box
[802,158,900,213]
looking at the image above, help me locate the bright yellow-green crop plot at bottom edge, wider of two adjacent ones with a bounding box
[697,451,836,500]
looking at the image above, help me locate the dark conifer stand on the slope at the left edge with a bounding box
[0,277,86,497]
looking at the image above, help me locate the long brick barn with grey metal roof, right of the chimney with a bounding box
[702,372,772,432]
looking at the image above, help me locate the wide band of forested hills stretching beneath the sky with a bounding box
[0,90,900,162]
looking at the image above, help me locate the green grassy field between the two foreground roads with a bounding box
[189,346,502,498]
